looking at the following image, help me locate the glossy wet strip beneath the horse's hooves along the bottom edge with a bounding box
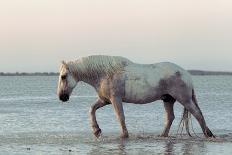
[0,133,232,155]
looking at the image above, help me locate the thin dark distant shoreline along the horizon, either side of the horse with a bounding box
[0,70,232,76]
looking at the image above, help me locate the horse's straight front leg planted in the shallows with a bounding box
[111,97,129,138]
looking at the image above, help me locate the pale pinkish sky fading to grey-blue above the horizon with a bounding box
[0,0,232,72]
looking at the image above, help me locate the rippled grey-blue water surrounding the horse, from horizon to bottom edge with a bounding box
[0,76,232,154]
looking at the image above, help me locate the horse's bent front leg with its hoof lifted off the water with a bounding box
[89,99,110,138]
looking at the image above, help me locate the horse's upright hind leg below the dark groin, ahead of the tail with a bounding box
[160,95,176,137]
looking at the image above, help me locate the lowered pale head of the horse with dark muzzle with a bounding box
[57,61,77,102]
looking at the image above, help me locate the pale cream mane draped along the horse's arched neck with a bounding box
[67,55,132,79]
